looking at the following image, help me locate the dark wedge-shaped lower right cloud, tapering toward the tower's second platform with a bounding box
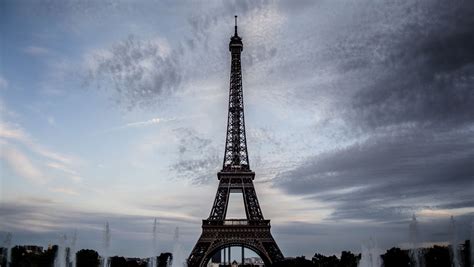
[275,126,474,222]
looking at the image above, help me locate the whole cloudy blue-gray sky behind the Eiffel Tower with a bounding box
[0,0,474,264]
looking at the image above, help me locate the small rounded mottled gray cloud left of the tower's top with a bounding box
[86,35,182,108]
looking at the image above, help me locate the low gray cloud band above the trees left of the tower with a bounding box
[0,201,199,257]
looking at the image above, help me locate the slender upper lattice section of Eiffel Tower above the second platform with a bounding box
[222,16,250,172]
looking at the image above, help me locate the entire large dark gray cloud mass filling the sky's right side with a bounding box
[266,1,474,228]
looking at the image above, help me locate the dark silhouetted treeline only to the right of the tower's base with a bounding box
[272,240,473,267]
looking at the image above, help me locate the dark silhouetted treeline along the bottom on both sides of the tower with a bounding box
[0,240,474,267]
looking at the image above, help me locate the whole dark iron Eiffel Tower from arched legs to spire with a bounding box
[188,16,283,267]
